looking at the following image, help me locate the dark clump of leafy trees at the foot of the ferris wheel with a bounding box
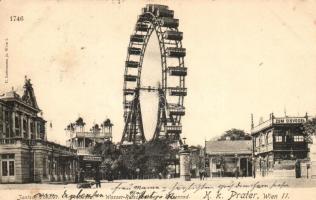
[92,140,178,178]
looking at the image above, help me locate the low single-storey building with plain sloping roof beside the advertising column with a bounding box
[205,140,252,177]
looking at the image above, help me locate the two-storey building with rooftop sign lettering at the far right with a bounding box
[251,113,308,177]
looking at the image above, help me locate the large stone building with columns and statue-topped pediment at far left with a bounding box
[0,78,77,183]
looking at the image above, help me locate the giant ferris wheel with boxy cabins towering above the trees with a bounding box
[121,4,187,145]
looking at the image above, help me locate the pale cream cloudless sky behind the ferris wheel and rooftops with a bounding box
[0,0,316,145]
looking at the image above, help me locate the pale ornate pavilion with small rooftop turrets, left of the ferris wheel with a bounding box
[66,117,113,178]
